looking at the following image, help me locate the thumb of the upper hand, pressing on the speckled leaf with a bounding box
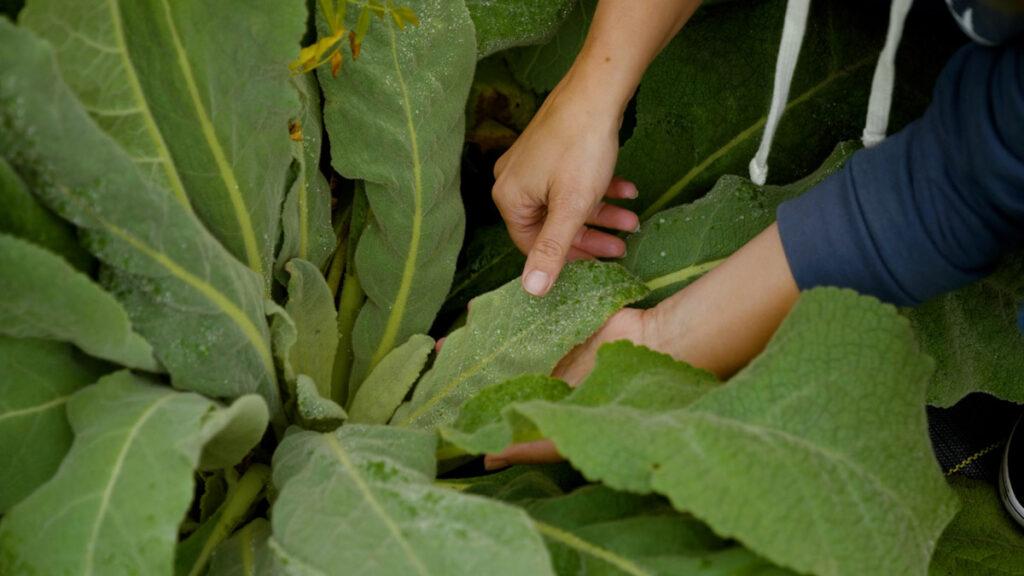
[522,203,587,296]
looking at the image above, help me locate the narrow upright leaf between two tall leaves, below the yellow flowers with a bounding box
[276,74,336,279]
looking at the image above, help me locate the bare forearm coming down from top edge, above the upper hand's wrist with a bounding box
[559,0,700,117]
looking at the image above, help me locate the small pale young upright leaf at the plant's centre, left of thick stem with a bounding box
[285,258,338,398]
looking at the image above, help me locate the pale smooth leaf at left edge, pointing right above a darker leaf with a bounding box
[0,234,160,372]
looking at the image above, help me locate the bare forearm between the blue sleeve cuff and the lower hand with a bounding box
[642,224,800,378]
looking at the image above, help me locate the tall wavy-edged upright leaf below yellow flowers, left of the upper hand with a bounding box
[321,0,476,389]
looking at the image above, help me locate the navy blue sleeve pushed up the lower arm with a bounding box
[777,43,1024,317]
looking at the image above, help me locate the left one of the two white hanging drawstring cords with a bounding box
[750,0,811,186]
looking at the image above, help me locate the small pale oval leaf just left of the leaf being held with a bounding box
[349,334,434,424]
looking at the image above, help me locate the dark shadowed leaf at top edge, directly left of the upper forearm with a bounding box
[506,0,597,92]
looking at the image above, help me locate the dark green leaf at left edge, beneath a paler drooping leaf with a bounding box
[0,336,105,515]
